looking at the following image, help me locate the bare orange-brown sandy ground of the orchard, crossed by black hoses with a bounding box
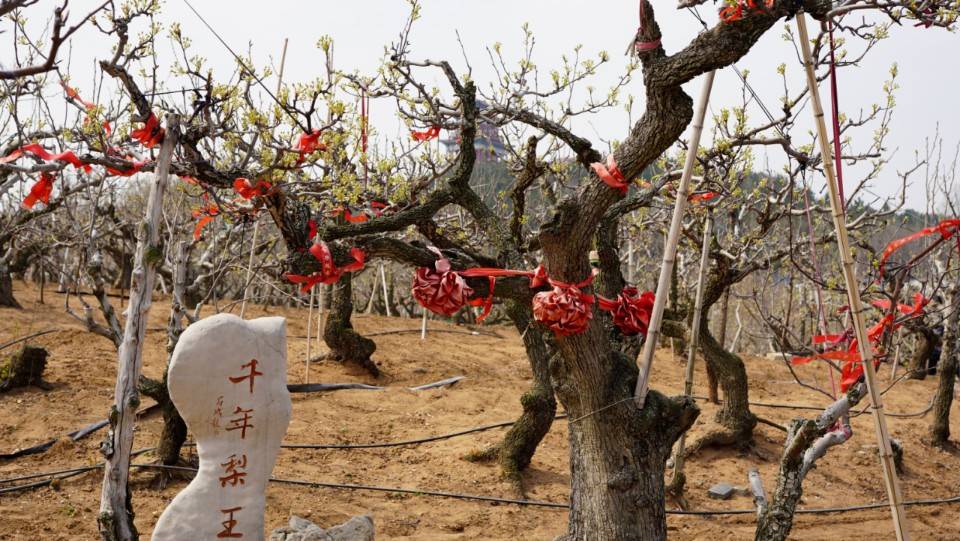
[0,284,960,541]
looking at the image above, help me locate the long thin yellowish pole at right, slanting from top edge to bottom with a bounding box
[797,12,910,541]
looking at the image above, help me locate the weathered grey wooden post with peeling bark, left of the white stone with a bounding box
[97,114,179,541]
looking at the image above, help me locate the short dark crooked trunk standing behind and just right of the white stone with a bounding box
[323,273,380,377]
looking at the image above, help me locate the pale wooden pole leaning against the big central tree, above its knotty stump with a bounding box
[633,71,716,408]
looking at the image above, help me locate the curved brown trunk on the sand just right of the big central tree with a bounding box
[690,319,757,453]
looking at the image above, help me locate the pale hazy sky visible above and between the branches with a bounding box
[37,0,960,207]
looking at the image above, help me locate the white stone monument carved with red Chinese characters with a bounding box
[153,314,291,541]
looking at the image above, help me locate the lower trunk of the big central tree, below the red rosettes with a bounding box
[552,344,699,541]
